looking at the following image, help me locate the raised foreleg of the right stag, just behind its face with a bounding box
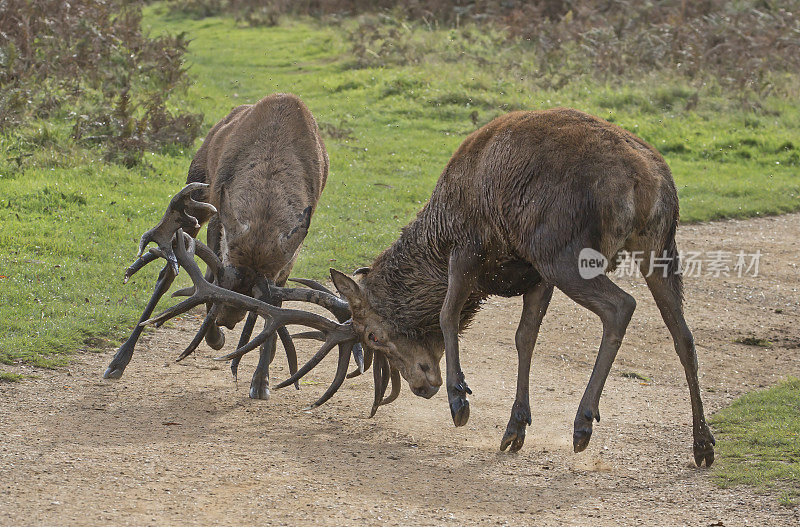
[439,250,478,426]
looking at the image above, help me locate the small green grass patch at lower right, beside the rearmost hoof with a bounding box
[711,379,800,505]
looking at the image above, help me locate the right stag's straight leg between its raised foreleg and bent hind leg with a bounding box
[500,281,553,452]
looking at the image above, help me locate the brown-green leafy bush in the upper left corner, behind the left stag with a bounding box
[0,0,202,166]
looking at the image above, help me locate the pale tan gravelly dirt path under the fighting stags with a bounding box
[0,215,800,526]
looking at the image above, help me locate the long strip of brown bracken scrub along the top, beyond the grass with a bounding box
[171,0,800,96]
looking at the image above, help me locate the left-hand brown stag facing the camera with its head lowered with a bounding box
[104,94,338,399]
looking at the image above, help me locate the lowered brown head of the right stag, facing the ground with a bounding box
[331,269,444,399]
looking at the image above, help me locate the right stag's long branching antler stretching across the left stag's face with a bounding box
[140,228,357,408]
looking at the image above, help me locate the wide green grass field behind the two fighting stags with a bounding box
[0,5,800,376]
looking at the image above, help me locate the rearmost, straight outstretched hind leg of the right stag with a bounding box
[640,248,715,467]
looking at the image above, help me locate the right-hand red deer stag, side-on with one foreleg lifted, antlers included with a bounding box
[145,109,714,466]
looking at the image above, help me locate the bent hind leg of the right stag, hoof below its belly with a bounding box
[540,245,636,452]
